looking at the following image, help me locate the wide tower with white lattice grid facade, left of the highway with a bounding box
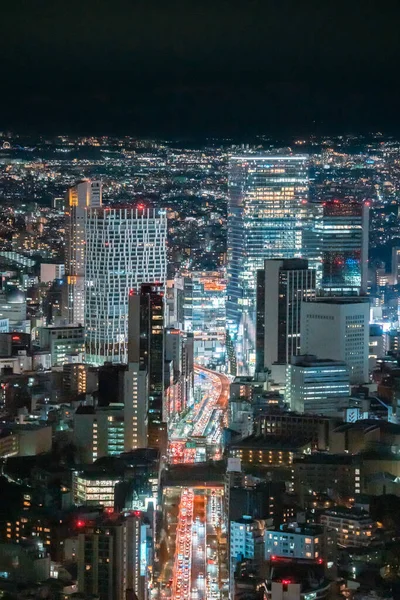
[85,208,167,365]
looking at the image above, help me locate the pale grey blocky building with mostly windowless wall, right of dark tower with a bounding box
[300,296,369,384]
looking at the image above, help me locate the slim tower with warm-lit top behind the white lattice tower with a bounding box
[65,180,102,325]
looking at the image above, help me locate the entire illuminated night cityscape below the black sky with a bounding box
[0,133,400,600]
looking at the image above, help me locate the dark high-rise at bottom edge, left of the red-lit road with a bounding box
[77,511,152,600]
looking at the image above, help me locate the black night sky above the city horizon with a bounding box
[0,0,400,139]
